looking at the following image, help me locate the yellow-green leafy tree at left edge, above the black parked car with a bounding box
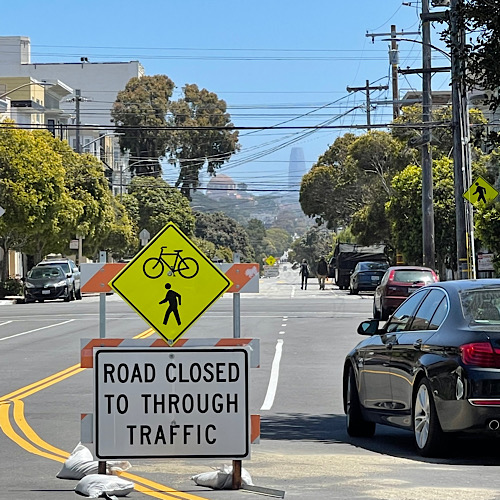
[0,124,79,281]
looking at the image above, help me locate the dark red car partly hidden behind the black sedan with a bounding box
[373,266,439,320]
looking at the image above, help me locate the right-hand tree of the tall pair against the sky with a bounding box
[167,84,239,198]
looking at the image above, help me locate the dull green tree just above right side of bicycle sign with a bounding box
[195,212,255,262]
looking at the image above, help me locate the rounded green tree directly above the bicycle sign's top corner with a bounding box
[123,176,195,237]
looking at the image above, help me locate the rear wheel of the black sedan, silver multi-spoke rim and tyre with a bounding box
[413,378,444,457]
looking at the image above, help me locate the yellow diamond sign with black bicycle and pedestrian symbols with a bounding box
[109,223,232,345]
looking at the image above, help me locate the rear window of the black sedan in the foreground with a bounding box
[460,288,500,326]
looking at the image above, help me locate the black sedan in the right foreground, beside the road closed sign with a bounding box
[343,279,500,456]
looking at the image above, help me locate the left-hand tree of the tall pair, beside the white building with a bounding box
[111,75,174,177]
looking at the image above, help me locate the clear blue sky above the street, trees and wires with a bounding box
[0,0,448,193]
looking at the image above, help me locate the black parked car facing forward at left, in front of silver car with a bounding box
[23,265,73,303]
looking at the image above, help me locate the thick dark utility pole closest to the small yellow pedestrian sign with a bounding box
[450,0,476,279]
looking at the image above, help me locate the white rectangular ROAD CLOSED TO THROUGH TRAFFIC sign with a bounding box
[94,347,250,460]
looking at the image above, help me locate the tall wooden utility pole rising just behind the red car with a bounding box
[421,0,436,269]
